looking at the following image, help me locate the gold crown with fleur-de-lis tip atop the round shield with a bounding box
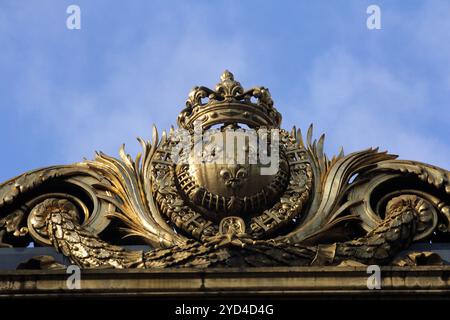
[178,70,281,131]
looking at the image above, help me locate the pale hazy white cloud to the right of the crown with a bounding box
[287,48,449,168]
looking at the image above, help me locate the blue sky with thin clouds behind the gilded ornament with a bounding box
[0,0,450,181]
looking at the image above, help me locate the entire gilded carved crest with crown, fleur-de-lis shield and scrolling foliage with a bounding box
[0,71,450,268]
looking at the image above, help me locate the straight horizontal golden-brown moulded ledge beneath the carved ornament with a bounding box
[0,266,450,299]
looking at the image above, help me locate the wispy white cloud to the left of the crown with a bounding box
[9,7,250,162]
